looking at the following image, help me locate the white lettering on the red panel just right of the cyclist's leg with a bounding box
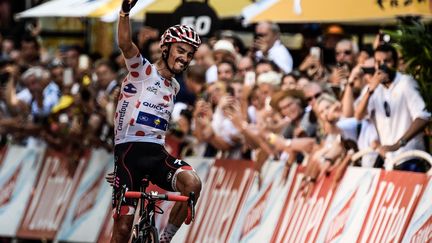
[190,167,253,242]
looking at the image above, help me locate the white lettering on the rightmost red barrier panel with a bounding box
[361,181,423,243]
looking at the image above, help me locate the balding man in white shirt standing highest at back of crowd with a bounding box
[253,22,293,73]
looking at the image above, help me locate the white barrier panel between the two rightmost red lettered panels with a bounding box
[316,167,381,242]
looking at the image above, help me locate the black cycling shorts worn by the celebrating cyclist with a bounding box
[113,142,192,207]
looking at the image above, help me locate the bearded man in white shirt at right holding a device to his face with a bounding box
[355,44,431,172]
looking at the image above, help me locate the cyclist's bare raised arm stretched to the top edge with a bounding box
[117,0,139,58]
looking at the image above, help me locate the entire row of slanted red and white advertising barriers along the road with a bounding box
[0,146,432,243]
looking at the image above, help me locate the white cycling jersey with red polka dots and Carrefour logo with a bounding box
[114,54,180,145]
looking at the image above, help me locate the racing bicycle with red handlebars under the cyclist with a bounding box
[115,176,195,243]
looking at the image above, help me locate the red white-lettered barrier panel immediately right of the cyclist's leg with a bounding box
[186,160,255,242]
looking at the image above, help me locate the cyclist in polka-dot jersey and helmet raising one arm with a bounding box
[111,0,201,243]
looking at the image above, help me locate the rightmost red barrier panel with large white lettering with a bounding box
[357,171,430,243]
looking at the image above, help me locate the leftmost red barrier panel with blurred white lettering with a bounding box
[17,149,88,239]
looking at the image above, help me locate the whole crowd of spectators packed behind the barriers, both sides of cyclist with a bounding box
[0,22,431,188]
